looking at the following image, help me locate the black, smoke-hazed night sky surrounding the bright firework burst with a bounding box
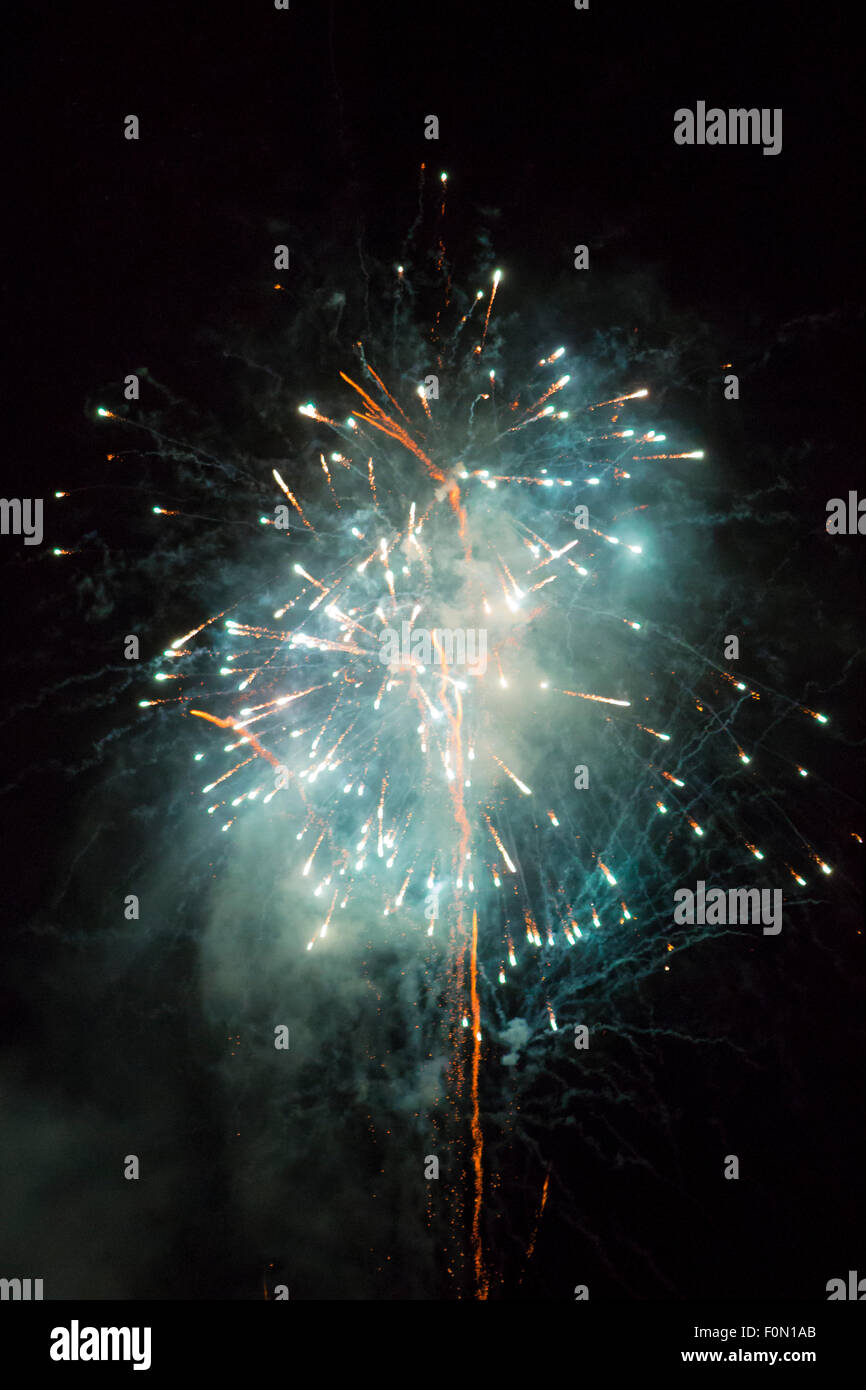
[0,0,866,1301]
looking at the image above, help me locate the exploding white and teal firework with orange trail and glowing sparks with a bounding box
[84,176,850,1297]
